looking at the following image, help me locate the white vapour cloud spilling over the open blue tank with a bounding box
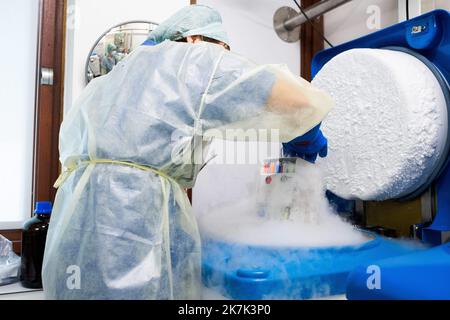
[200,160,369,247]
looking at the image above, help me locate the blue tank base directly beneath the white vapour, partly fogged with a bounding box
[202,234,424,300]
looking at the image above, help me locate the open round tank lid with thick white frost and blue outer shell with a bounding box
[313,10,450,205]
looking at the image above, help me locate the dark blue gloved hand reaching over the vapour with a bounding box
[283,124,328,163]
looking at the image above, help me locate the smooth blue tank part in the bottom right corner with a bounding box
[347,244,450,300]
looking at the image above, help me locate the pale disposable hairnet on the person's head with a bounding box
[149,5,229,45]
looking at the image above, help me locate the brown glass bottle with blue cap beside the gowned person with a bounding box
[20,202,52,289]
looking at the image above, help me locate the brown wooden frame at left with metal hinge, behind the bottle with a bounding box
[0,0,67,254]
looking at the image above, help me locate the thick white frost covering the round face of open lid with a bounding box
[313,49,448,200]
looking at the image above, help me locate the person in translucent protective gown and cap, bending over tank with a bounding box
[42,5,333,299]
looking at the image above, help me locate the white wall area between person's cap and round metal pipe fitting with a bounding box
[197,0,300,74]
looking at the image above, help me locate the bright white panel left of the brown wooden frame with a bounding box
[0,0,39,228]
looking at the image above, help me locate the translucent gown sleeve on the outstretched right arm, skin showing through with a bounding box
[201,52,334,142]
